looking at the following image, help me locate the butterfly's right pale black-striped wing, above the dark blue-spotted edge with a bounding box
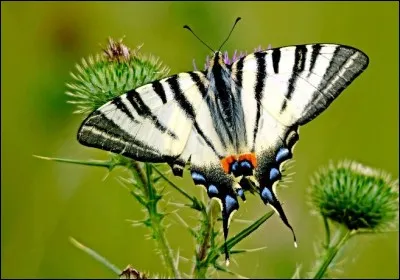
[232,44,368,154]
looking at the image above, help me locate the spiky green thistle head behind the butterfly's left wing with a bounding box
[67,38,169,114]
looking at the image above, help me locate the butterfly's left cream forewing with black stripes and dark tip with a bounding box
[78,72,207,162]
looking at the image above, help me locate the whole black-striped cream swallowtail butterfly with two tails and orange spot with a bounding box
[78,18,368,261]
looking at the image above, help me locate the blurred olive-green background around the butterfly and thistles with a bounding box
[1,2,399,278]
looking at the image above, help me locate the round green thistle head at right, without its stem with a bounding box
[309,161,399,231]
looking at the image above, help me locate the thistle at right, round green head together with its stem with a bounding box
[309,161,399,279]
